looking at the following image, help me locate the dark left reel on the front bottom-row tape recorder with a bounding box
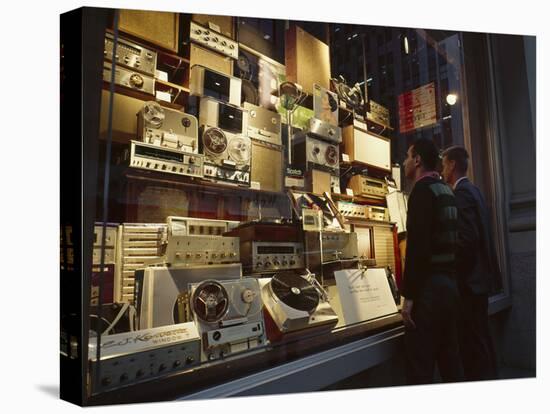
[191,280,229,323]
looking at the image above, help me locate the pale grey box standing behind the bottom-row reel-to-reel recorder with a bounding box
[136,263,242,329]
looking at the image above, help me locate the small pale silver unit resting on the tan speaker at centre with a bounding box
[244,102,282,146]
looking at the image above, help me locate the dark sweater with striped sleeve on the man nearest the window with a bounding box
[403,177,457,300]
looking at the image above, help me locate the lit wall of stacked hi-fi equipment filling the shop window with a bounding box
[61,10,412,398]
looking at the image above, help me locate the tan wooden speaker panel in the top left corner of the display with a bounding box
[119,9,179,53]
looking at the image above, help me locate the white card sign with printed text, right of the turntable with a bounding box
[334,268,397,325]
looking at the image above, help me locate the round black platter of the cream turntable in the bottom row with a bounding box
[271,272,319,313]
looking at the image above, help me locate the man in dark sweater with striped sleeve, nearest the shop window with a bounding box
[402,139,462,384]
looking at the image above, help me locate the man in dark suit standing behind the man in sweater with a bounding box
[442,146,498,381]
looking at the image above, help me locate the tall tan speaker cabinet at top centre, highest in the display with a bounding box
[285,25,330,95]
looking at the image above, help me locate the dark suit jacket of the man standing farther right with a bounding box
[454,178,500,295]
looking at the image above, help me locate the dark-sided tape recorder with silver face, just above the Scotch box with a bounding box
[293,133,340,173]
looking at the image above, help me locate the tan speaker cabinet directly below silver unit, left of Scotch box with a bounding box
[250,140,283,192]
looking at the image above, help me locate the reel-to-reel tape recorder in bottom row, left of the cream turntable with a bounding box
[190,278,266,361]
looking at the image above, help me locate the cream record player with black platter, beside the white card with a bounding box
[259,270,338,341]
